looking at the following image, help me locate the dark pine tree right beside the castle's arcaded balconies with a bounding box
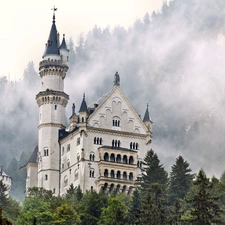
[141,149,168,194]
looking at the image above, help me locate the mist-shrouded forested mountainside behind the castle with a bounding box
[0,0,225,203]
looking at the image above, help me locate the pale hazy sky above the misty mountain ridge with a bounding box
[0,0,162,80]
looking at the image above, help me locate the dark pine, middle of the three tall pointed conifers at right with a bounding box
[169,156,194,203]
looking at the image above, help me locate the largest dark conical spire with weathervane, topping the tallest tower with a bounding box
[43,6,59,57]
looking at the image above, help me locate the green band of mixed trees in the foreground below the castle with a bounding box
[0,149,225,225]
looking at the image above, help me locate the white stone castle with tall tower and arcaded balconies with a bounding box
[26,13,152,195]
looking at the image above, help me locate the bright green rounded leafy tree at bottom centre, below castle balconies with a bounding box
[98,198,128,225]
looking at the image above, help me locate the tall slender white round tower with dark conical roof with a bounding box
[36,7,69,194]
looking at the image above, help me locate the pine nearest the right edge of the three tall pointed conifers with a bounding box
[187,170,221,225]
